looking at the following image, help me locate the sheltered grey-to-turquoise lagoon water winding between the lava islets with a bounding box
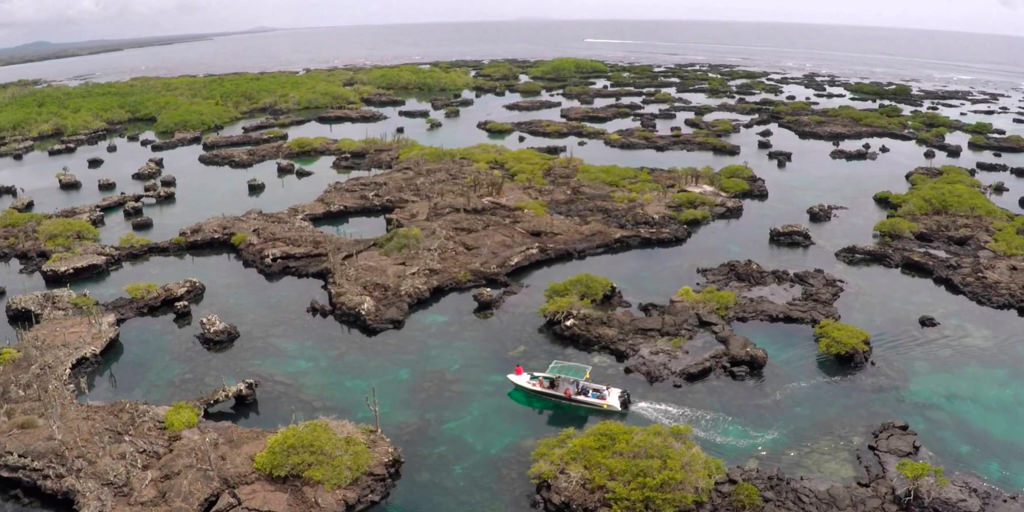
[0,68,1024,511]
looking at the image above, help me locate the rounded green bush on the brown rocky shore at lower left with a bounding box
[253,420,373,490]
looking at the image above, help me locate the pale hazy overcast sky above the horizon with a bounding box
[0,0,1024,46]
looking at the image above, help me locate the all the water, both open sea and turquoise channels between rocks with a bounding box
[0,22,1024,512]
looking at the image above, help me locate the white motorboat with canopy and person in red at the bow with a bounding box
[508,360,630,412]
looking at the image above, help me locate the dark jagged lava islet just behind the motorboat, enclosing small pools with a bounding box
[546,260,843,386]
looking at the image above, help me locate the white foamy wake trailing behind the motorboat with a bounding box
[630,401,778,446]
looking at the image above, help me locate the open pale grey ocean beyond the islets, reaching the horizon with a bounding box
[0,20,1024,86]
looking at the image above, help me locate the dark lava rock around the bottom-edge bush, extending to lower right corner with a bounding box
[534,421,1024,512]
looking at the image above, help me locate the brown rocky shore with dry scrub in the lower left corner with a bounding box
[0,280,401,512]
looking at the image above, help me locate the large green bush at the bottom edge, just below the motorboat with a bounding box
[528,421,725,512]
